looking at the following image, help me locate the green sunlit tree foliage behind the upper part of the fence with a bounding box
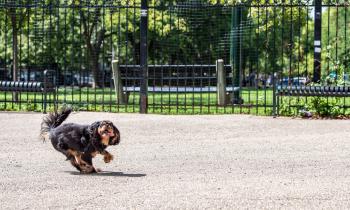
[0,0,349,87]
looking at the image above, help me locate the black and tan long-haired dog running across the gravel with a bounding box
[40,107,120,173]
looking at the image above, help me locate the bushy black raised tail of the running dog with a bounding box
[40,107,72,141]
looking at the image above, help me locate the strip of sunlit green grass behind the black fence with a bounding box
[0,87,350,115]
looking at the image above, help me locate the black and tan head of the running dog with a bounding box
[90,120,120,146]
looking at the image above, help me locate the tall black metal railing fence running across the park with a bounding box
[0,0,350,115]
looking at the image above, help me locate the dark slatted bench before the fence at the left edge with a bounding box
[0,70,56,113]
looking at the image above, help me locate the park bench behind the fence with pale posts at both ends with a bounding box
[112,59,243,105]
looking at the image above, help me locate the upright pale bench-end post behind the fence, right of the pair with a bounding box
[216,59,226,106]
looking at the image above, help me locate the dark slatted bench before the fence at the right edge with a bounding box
[276,86,350,115]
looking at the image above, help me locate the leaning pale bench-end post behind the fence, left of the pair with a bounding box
[112,60,128,104]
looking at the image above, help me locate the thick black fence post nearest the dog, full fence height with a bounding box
[140,0,148,114]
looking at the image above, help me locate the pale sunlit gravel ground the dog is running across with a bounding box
[0,112,350,209]
